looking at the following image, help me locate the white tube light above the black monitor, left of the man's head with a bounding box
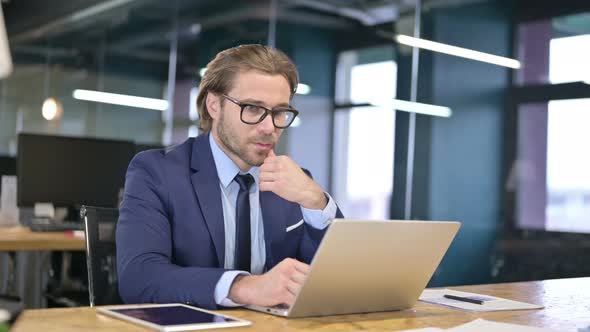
[72,89,168,111]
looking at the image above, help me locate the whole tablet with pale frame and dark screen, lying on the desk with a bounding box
[96,303,252,332]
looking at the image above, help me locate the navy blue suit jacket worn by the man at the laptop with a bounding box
[117,134,342,308]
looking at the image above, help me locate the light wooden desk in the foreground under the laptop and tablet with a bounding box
[12,278,590,332]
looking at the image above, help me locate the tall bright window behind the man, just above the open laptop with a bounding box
[333,46,397,219]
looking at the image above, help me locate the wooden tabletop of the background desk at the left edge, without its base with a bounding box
[0,227,85,251]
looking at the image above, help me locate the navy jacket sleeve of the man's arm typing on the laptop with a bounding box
[116,152,225,309]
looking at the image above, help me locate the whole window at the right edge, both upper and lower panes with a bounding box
[508,14,590,233]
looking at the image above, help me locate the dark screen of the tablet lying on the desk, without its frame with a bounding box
[110,306,238,326]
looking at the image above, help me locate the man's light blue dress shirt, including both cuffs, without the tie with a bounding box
[209,135,336,306]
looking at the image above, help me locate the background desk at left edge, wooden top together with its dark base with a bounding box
[0,227,85,308]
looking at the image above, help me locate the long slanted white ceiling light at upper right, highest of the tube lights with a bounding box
[395,35,520,69]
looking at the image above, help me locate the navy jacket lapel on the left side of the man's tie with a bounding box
[191,135,225,267]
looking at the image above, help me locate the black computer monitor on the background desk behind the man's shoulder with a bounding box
[17,134,134,209]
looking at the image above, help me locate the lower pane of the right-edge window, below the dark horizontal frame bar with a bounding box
[513,98,590,233]
